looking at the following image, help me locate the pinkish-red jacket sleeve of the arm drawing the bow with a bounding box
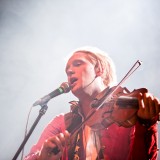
[24,114,65,160]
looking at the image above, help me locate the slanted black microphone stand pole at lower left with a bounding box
[12,104,48,160]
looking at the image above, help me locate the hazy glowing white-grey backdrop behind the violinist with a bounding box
[0,0,160,160]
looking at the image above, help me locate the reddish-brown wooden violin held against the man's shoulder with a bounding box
[85,87,147,130]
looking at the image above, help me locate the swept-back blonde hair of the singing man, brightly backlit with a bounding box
[72,46,117,86]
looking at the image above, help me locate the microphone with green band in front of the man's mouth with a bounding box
[33,82,70,106]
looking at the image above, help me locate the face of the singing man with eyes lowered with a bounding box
[66,52,96,95]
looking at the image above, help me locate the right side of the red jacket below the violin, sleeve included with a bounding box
[101,122,158,160]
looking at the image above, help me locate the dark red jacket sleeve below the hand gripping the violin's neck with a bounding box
[129,116,158,160]
